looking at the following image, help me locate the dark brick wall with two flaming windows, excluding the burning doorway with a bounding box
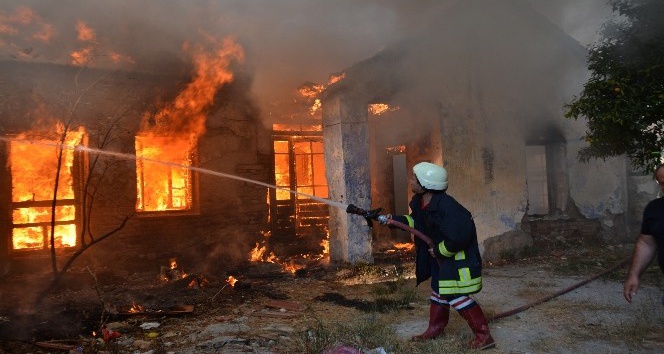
[0,49,280,272]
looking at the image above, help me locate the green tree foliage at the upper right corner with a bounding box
[565,0,664,170]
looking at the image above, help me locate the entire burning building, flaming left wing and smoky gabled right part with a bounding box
[0,1,660,280]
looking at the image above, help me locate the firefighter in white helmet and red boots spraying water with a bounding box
[379,162,496,349]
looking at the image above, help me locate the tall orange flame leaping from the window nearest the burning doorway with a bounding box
[136,39,244,211]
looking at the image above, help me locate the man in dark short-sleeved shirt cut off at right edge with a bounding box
[623,164,664,303]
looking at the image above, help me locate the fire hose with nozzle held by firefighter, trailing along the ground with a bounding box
[346,204,630,321]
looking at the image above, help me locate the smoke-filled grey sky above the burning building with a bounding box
[0,0,611,118]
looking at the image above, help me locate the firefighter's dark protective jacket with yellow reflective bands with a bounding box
[394,192,482,295]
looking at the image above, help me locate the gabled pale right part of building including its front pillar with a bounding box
[322,1,654,262]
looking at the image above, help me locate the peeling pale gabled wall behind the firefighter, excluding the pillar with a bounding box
[324,0,632,258]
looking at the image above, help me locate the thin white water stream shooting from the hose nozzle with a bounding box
[0,137,348,210]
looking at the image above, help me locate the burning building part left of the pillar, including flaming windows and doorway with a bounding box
[0,33,328,276]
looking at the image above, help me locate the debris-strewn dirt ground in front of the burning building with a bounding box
[0,245,664,354]
